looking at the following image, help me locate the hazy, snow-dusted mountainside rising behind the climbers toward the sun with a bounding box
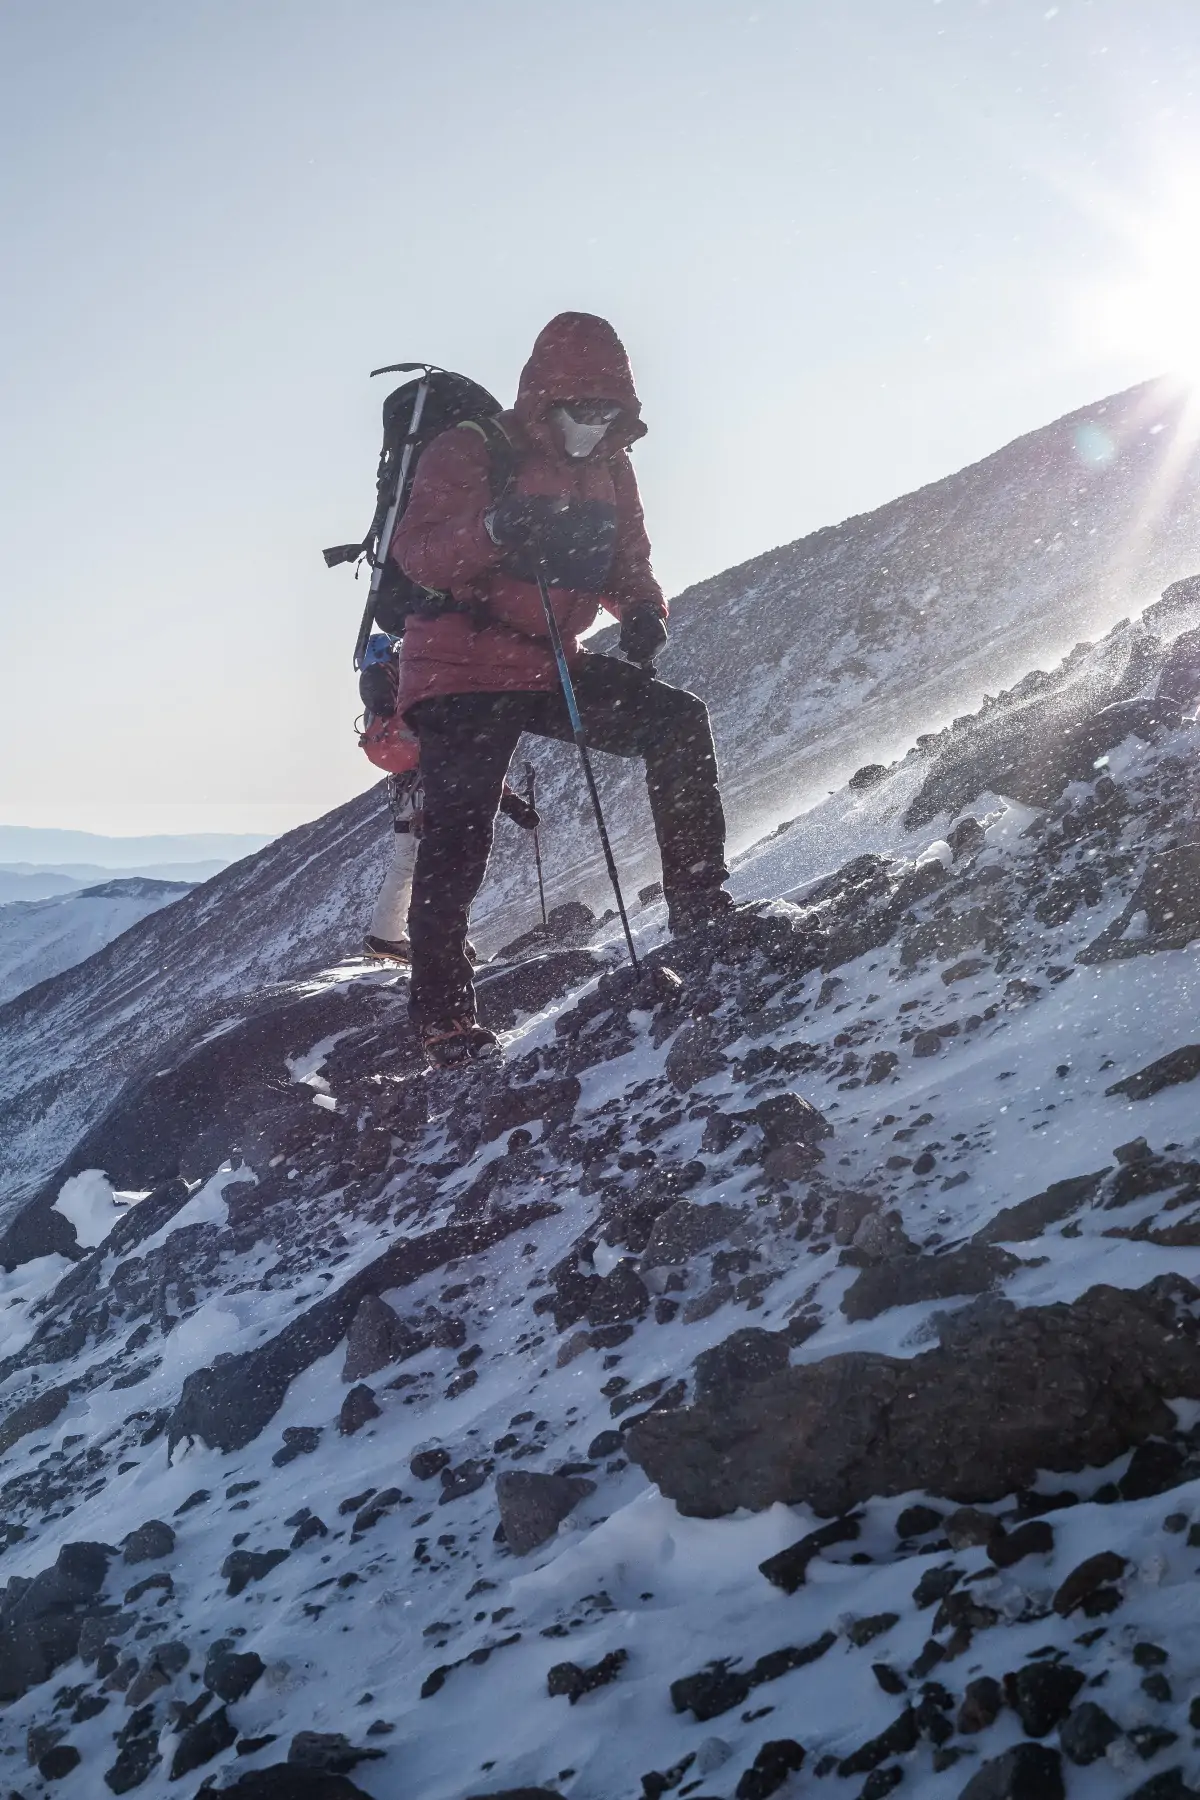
[0,383,1200,1222]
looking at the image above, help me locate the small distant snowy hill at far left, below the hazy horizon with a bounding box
[0,875,189,1004]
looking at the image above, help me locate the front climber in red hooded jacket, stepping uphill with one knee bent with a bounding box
[390,313,732,1064]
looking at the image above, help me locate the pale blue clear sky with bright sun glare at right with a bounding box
[0,0,1200,833]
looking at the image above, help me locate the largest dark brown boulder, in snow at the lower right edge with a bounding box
[626,1276,1200,1517]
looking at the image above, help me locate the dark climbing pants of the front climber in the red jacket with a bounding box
[408,653,729,1024]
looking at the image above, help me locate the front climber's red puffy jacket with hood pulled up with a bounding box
[390,313,667,711]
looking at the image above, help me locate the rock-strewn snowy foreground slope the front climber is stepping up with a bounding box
[0,583,1200,1800]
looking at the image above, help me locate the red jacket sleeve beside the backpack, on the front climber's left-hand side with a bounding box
[390,427,502,589]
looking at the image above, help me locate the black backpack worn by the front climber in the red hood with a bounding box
[324,362,515,668]
